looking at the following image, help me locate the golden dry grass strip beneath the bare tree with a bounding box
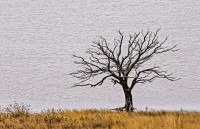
[0,105,200,129]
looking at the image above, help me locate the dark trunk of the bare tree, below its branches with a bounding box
[124,89,134,111]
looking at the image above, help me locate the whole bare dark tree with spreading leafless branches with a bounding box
[70,30,176,111]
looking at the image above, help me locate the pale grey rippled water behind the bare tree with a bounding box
[0,0,200,111]
